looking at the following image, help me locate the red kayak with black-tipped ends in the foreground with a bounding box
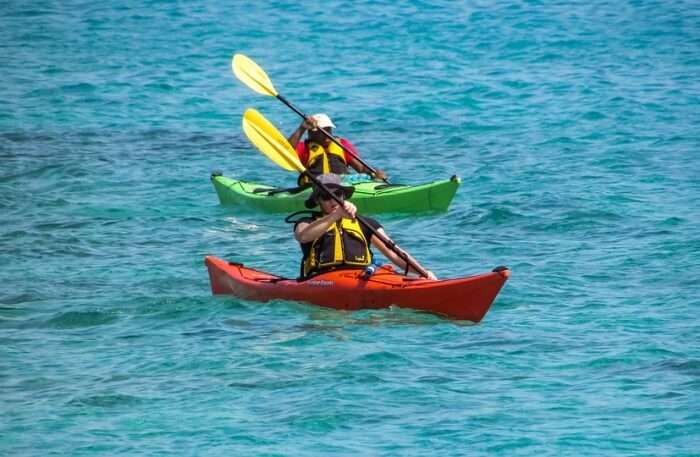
[204,256,510,322]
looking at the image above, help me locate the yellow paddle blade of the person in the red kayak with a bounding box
[243,108,304,173]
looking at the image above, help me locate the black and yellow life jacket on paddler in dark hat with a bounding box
[301,214,372,277]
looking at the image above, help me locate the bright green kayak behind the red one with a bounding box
[211,173,460,214]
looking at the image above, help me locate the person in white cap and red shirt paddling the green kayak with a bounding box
[287,113,386,186]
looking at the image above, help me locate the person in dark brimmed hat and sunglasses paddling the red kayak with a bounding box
[294,173,437,279]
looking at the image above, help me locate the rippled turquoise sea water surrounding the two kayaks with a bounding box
[0,0,700,456]
